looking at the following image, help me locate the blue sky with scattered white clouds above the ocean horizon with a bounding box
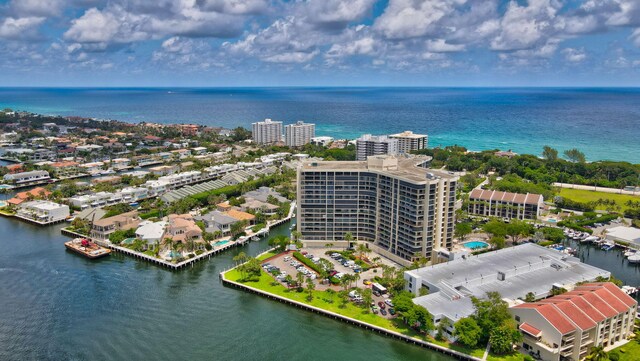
[0,0,640,87]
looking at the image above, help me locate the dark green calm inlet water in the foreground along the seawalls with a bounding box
[0,217,451,361]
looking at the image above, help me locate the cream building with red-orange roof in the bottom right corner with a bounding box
[509,282,638,361]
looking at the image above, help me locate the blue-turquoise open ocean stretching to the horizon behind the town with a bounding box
[0,88,640,163]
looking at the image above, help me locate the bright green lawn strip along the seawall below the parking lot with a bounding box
[225,268,488,361]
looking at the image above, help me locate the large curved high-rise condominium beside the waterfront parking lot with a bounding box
[297,155,458,264]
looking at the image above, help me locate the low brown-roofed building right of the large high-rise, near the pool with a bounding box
[468,188,544,219]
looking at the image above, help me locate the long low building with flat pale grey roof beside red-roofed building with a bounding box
[404,243,611,332]
